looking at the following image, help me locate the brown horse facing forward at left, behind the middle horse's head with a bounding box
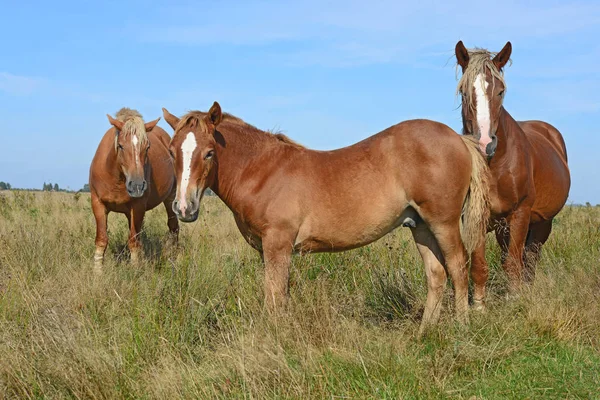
[90,108,179,266]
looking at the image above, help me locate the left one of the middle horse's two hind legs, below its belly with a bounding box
[411,222,447,335]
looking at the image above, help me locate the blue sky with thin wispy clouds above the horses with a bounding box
[0,0,600,204]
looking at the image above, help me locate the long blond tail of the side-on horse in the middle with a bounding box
[460,135,491,256]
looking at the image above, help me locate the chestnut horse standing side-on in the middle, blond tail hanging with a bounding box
[163,102,489,331]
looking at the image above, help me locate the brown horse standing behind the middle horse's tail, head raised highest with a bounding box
[456,41,571,307]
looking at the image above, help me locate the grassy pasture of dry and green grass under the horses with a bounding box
[0,192,600,399]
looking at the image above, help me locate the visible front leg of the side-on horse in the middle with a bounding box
[262,231,293,311]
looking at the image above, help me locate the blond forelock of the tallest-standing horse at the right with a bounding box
[456,48,512,110]
